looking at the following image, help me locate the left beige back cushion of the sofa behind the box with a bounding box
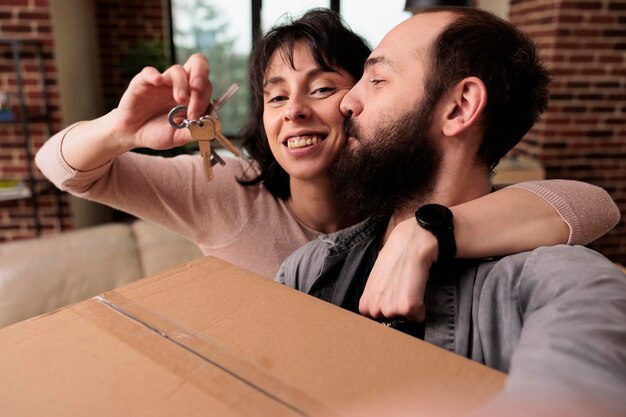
[0,224,143,327]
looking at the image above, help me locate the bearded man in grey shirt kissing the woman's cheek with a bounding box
[278,5,626,414]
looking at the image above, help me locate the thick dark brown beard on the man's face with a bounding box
[330,100,441,218]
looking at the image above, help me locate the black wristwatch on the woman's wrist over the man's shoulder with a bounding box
[415,204,456,263]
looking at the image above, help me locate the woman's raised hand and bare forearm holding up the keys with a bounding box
[61,54,212,171]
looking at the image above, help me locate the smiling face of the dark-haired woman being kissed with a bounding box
[263,42,356,181]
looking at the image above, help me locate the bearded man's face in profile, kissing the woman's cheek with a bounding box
[331,13,452,214]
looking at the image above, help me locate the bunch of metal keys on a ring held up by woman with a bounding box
[167,84,241,181]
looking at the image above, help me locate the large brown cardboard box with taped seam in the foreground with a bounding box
[0,257,505,417]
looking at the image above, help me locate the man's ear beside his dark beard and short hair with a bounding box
[442,77,487,136]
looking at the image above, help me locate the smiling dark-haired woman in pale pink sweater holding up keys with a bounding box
[36,10,616,277]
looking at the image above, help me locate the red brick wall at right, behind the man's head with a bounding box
[510,0,626,264]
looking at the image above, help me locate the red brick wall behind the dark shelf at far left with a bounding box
[0,0,66,241]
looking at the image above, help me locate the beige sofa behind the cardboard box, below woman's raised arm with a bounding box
[0,220,202,328]
